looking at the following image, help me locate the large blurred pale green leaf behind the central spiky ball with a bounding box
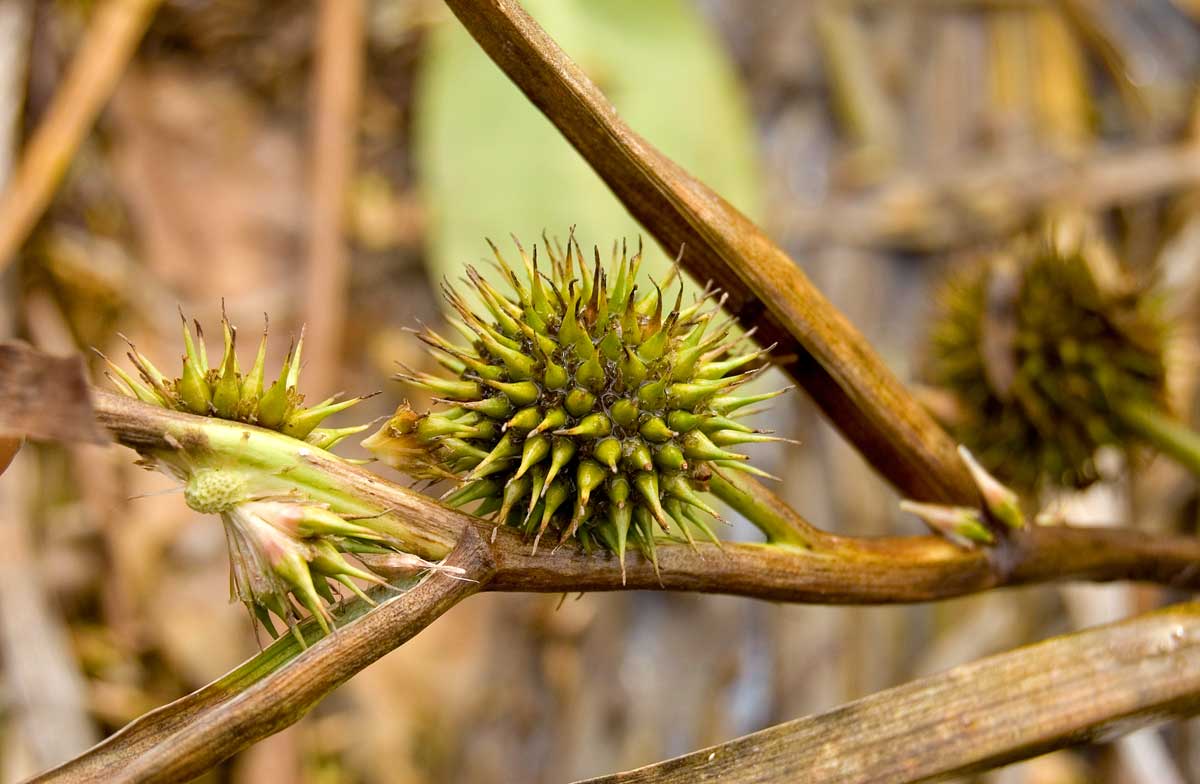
[415,0,761,280]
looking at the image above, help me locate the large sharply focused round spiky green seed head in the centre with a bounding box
[364,232,780,569]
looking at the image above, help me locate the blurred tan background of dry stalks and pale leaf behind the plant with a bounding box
[0,0,1200,784]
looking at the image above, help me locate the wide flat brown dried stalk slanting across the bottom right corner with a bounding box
[587,603,1200,784]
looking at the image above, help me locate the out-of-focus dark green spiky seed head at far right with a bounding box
[929,223,1165,492]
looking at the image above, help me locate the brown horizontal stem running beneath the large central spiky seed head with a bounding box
[94,391,1200,604]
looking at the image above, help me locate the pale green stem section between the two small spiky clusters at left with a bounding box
[151,418,455,561]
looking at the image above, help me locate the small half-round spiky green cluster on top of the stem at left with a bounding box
[101,313,366,449]
